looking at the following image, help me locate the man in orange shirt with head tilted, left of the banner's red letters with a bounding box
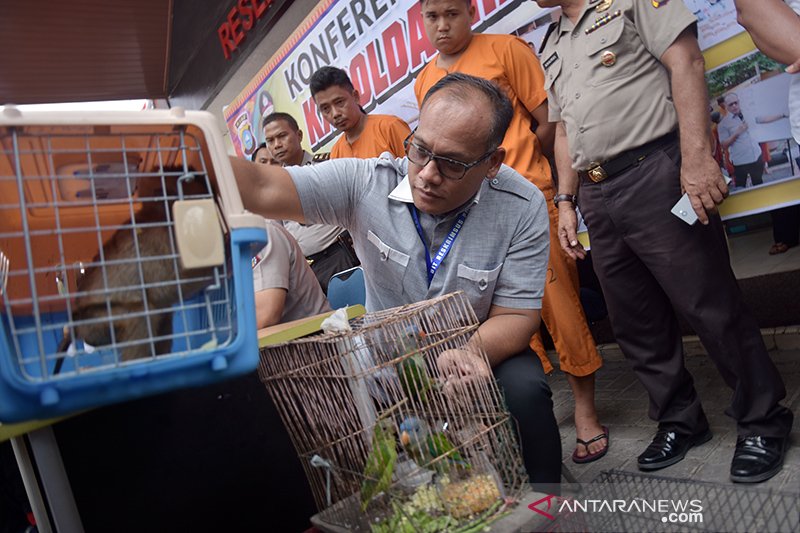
[309,67,411,159]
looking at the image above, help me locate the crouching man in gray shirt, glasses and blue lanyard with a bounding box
[232,74,561,483]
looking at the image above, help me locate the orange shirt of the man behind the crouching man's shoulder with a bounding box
[331,115,411,159]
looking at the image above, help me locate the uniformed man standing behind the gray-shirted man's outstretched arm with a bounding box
[262,113,361,294]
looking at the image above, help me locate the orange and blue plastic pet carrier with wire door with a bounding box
[0,106,266,422]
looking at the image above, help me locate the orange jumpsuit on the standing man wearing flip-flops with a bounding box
[414,34,603,376]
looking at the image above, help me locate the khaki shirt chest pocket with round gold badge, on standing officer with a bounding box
[586,15,636,87]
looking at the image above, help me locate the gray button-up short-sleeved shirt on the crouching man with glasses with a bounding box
[286,153,549,322]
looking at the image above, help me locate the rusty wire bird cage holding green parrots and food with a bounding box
[259,292,526,533]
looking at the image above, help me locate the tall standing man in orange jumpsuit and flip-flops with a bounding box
[414,0,608,463]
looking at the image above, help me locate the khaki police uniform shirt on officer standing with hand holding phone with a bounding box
[540,0,696,170]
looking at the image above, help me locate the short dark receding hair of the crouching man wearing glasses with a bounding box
[420,72,514,149]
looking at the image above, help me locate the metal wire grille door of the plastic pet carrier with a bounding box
[0,128,235,382]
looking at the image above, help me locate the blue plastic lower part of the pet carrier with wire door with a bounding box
[0,227,266,422]
